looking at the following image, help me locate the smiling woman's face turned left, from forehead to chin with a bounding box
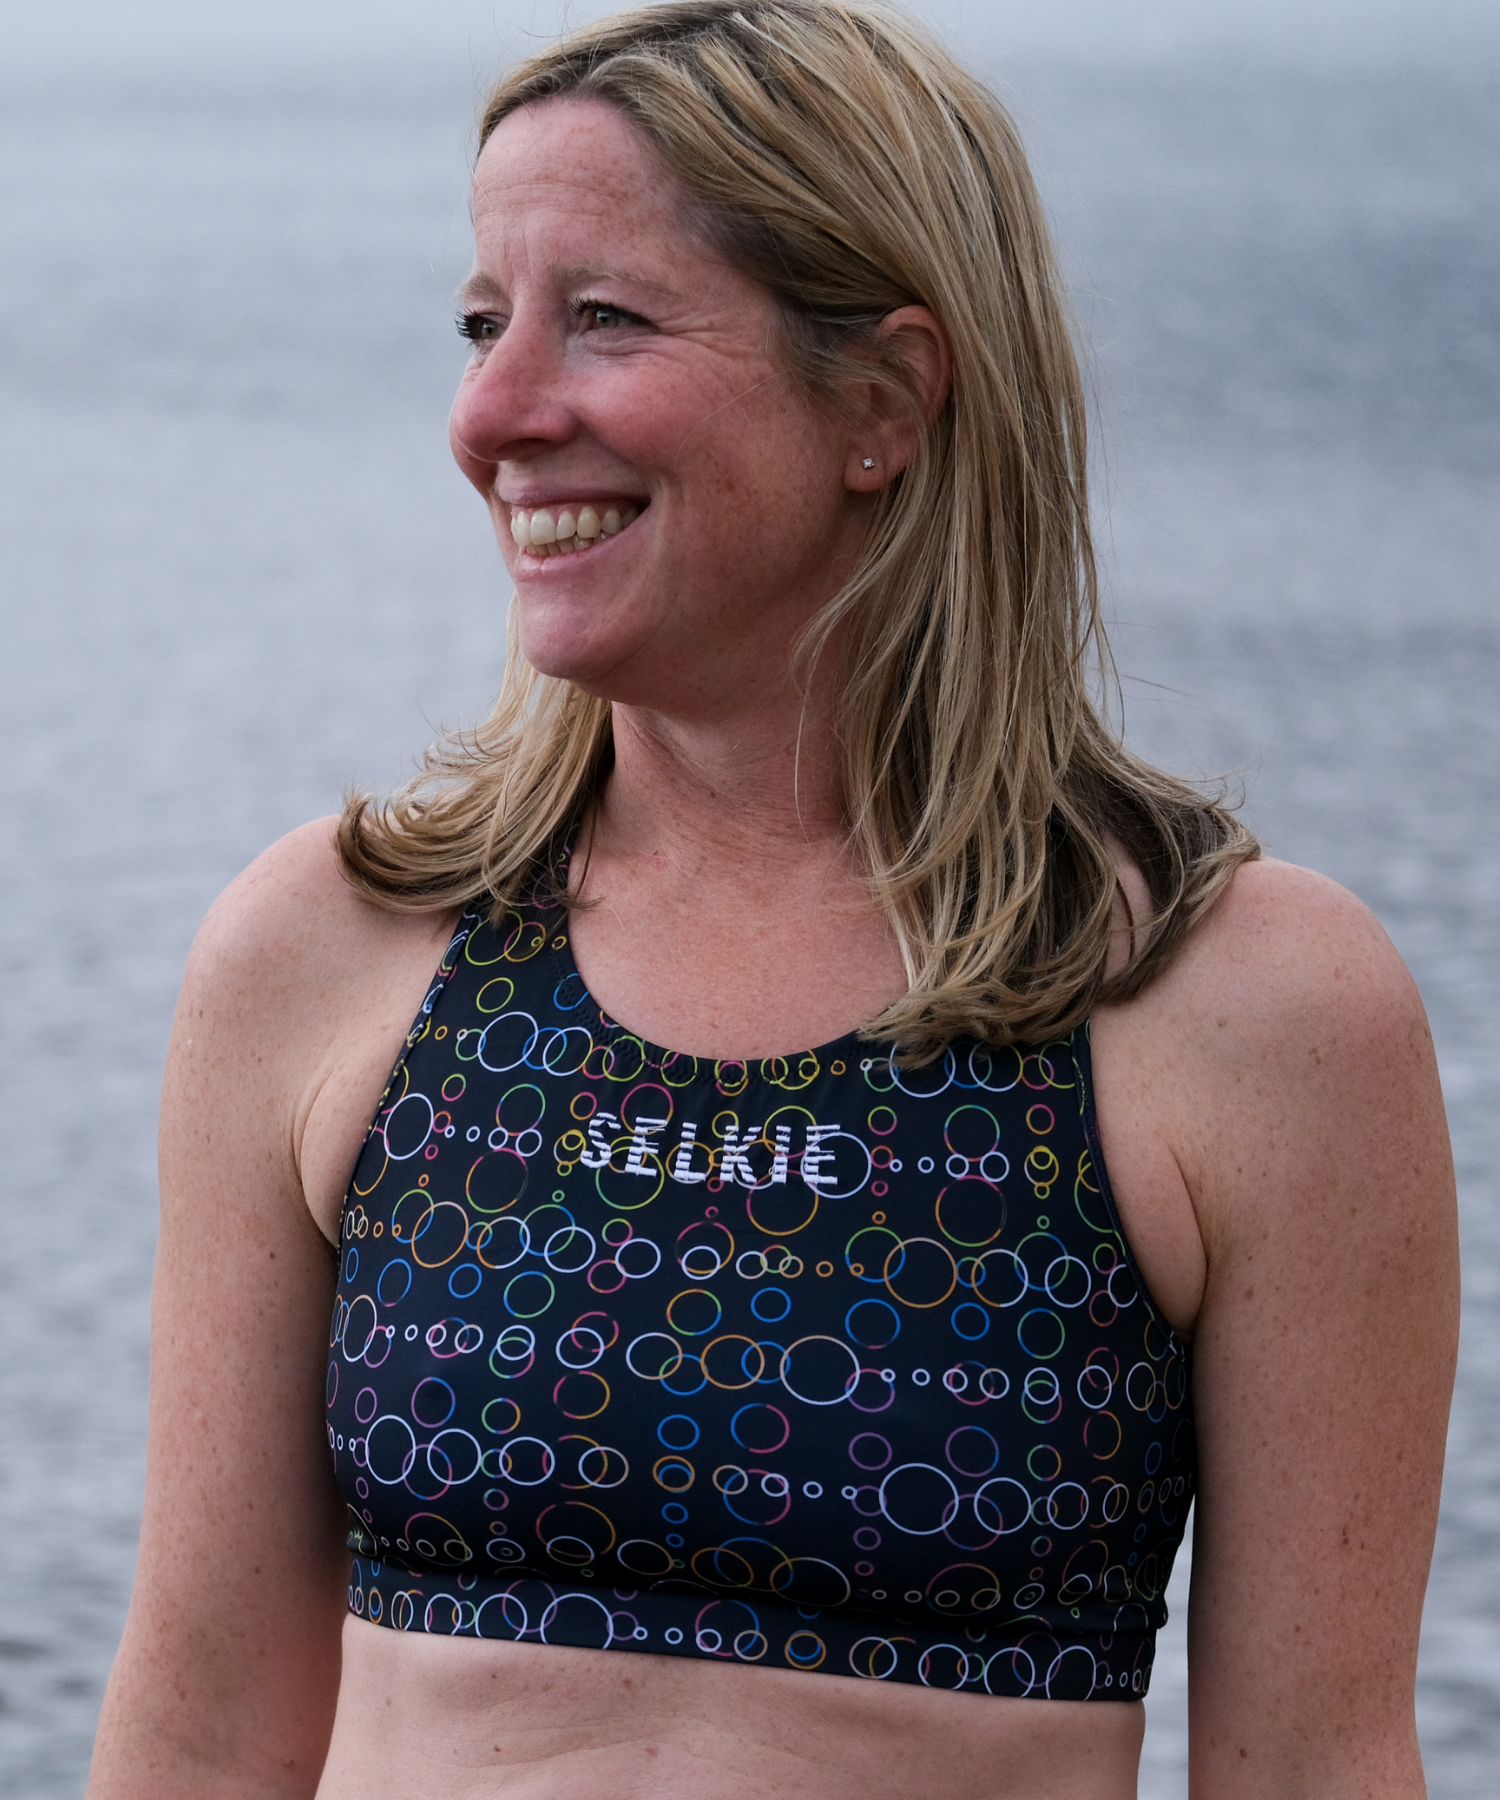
[452,99,868,716]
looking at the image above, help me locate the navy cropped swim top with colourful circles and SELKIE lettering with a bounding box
[328,856,1194,1699]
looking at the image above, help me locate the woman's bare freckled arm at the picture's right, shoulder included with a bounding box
[1176,866,1457,1800]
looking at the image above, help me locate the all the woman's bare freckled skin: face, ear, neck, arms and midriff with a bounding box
[90,87,1457,1800]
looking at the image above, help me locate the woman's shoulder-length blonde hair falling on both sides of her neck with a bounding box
[339,0,1259,1060]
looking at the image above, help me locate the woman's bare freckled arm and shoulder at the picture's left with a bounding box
[88,824,450,1800]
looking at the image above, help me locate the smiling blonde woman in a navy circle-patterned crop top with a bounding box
[90,0,1455,1800]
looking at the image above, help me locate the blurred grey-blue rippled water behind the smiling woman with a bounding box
[0,0,1500,1800]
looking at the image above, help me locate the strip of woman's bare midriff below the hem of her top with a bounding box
[317,1618,1145,1800]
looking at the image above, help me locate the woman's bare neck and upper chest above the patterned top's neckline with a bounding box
[569,687,906,1058]
